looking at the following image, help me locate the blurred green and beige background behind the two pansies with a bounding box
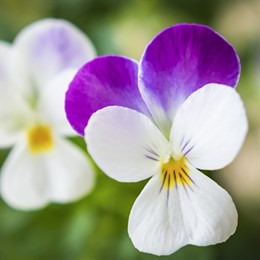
[0,0,260,260]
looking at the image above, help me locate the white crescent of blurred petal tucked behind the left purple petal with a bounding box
[39,70,76,136]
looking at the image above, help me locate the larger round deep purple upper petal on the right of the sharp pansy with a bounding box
[139,24,240,133]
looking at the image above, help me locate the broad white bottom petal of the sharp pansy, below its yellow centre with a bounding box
[128,165,237,255]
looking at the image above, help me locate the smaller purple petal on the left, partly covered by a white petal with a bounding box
[65,56,149,135]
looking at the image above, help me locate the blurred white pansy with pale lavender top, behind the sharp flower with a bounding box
[0,19,95,210]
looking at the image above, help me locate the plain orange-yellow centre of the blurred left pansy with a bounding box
[27,125,53,153]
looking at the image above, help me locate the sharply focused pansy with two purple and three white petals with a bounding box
[65,24,247,255]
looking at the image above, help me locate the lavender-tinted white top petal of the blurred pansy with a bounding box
[14,19,95,86]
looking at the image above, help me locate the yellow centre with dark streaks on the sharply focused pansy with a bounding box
[161,157,192,189]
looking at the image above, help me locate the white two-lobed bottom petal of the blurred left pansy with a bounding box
[1,137,94,210]
